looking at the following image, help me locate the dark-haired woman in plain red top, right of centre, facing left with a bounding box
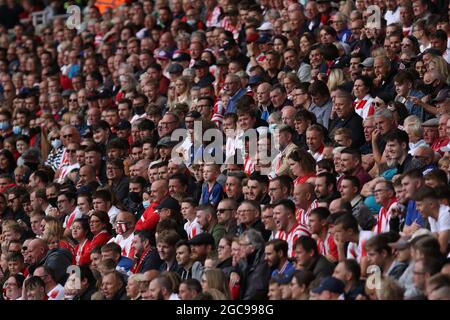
[288,149,316,186]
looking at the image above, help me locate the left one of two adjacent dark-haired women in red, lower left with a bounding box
[71,218,92,266]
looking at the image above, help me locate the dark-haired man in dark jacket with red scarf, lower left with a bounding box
[130,231,162,276]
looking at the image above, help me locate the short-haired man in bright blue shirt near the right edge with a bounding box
[401,169,425,236]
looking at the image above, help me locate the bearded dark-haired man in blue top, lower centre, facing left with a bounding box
[264,239,295,277]
